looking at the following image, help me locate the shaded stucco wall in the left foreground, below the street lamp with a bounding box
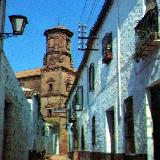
[0,50,30,160]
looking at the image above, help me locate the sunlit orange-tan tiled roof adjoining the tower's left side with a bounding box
[16,68,41,78]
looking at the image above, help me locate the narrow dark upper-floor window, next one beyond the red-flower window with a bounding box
[89,63,94,91]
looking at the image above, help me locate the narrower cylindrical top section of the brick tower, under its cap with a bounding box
[44,26,73,69]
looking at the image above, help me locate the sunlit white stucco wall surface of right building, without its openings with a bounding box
[67,0,160,159]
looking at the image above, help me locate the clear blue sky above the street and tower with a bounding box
[4,0,104,72]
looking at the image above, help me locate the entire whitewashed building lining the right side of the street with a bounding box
[66,0,160,160]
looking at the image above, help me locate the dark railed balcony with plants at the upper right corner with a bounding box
[135,7,160,60]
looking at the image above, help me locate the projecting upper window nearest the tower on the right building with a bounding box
[76,86,83,110]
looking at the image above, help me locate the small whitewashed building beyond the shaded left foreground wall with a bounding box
[22,88,58,155]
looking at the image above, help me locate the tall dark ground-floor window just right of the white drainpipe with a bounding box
[124,97,135,154]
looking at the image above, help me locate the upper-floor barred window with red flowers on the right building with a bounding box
[102,33,112,64]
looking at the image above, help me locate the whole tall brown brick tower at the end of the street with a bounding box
[41,26,75,154]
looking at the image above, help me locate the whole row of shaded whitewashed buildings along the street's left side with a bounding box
[0,0,56,160]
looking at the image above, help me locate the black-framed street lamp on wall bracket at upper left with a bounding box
[0,15,28,39]
